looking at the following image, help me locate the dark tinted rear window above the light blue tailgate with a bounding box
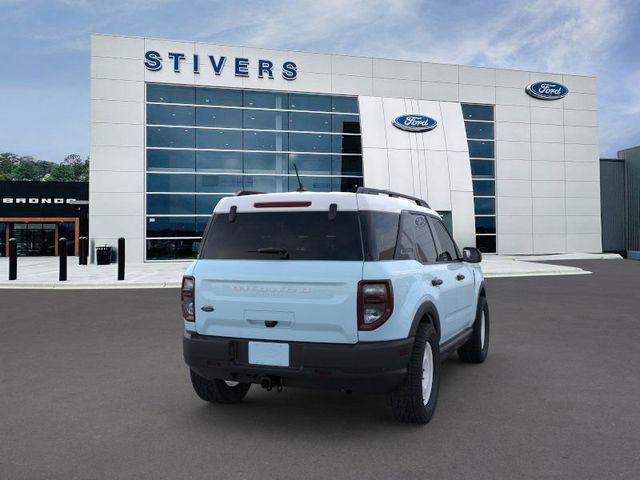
[199,211,363,261]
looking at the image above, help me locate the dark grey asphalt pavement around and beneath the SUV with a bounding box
[0,260,640,480]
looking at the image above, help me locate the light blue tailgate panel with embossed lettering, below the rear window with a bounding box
[194,260,362,343]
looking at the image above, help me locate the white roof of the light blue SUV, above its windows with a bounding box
[214,192,439,216]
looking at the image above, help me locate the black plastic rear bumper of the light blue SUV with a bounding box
[182,332,414,393]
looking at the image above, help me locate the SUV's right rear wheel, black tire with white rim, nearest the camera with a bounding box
[387,323,440,424]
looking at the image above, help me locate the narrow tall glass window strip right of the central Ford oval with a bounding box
[462,104,496,253]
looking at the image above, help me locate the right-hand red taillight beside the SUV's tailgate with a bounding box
[358,280,393,330]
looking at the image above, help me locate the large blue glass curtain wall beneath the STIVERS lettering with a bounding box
[146,84,362,260]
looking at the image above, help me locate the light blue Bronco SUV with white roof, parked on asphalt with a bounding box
[181,188,489,423]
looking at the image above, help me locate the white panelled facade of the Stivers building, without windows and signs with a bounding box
[89,34,602,261]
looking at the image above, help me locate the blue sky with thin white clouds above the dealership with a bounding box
[0,0,640,162]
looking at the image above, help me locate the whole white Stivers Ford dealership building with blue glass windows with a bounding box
[89,34,602,261]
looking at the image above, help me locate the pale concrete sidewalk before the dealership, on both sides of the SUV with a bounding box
[0,254,620,289]
